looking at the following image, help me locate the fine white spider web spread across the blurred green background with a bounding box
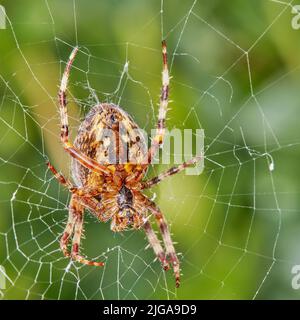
[0,0,300,299]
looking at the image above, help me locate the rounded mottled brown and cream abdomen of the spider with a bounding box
[72,103,147,186]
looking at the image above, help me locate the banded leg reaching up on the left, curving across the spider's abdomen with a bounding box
[58,47,111,175]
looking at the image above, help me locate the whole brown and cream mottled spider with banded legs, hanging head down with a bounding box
[47,41,200,287]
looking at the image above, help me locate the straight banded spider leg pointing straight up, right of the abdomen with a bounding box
[146,41,170,164]
